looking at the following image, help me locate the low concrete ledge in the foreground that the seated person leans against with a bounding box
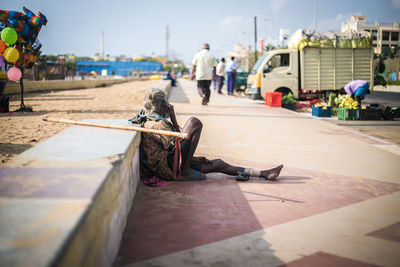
[0,120,140,266]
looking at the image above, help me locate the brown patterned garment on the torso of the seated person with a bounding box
[141,120,176,180]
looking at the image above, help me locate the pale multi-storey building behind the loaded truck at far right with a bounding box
[342,16,400,54]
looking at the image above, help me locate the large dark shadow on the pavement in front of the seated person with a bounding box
[116,178,283,266]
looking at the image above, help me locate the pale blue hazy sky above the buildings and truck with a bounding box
[0,0,400,64]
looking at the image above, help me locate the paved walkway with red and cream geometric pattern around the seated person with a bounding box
[116,80,400,266]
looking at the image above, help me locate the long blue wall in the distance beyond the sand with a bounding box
[76,60,162,76]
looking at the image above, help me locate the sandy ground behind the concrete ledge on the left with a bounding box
[0,81,158,165]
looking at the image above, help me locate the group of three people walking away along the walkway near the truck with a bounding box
[190,44,237,105]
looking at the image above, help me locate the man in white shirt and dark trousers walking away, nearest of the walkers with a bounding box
[190,44,216,105]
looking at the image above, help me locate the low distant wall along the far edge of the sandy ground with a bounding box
[4,78,147,94]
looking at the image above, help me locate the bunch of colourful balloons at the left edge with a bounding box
[0,7,47,81]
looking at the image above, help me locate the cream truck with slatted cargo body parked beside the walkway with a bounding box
[247,29,374,99]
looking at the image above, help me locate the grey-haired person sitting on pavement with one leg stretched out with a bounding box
[132,88,283,181]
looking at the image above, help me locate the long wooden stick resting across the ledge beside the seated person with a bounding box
[43,116,189,139]
